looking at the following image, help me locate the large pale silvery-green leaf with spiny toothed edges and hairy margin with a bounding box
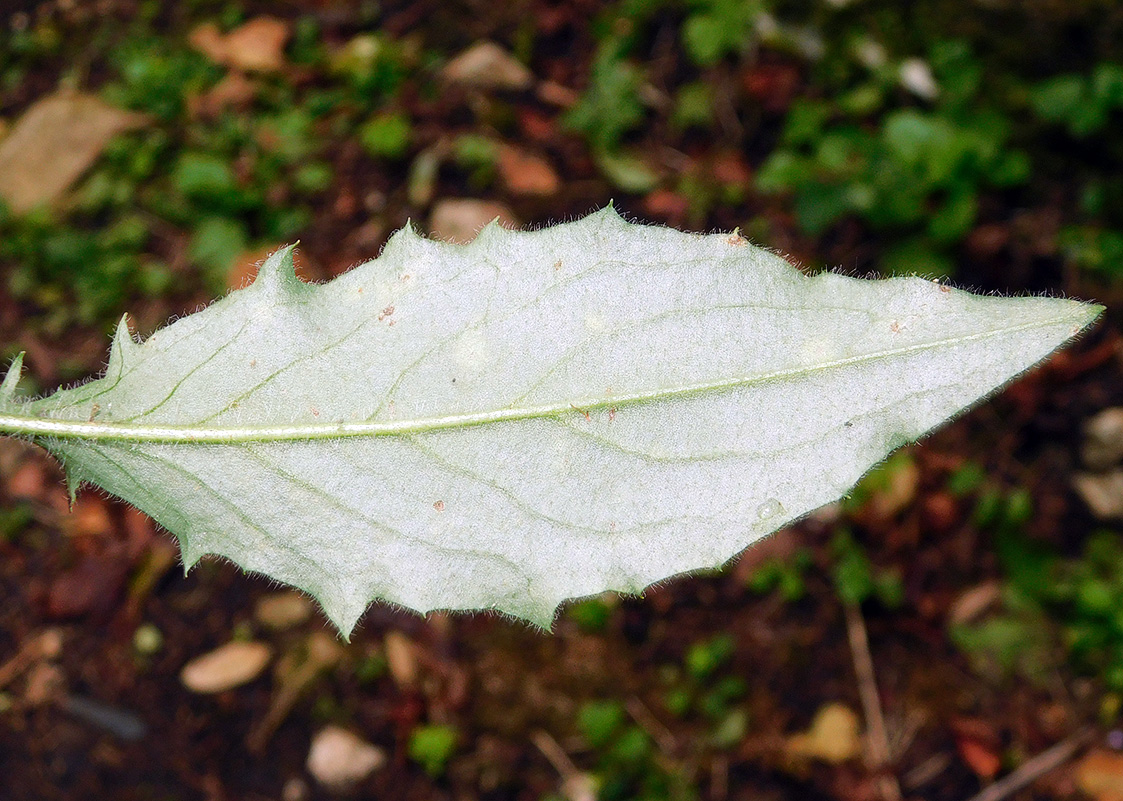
[0,208,1101,634]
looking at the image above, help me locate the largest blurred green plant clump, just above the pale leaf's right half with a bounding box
[757,45,1030,275]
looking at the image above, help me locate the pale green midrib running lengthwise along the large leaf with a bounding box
[0,315,1094,445]
